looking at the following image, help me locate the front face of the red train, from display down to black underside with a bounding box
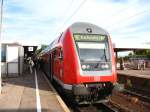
[69,22,116,103]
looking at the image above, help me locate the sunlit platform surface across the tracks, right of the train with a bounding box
[117,68,150,79]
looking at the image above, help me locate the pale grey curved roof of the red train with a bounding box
[41,22,109,55]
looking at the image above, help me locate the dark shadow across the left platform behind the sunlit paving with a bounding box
[2,70,52,91]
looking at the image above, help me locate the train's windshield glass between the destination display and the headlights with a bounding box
[77,42,110,62]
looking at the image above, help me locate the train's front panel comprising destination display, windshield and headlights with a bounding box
[74,34,111,71]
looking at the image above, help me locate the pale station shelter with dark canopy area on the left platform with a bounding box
[1,43,37,77]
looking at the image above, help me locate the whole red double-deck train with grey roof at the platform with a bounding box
[41,22,117,103]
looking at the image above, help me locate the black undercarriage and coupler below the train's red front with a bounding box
[69,82,113,104]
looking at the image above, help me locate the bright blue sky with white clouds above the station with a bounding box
[2,0,150,47]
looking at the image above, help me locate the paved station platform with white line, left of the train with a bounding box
[0,71,69,112]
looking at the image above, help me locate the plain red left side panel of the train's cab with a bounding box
[63,29,79,84]
